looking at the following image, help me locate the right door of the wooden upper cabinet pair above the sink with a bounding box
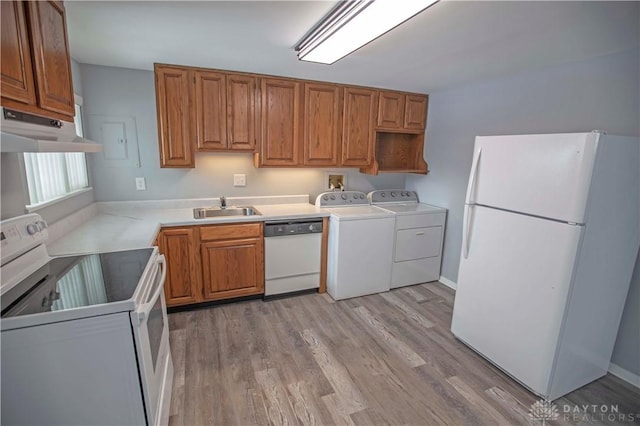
[227,74,256,151]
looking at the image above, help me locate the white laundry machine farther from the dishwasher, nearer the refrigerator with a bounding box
[367,189,447,288]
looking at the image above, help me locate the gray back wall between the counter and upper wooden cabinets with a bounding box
[80,64,405,201]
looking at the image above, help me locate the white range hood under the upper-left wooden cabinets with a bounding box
[0,108,102,152]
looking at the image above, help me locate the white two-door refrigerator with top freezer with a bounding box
[451,132,640,400]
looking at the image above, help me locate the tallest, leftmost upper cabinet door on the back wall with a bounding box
[155,65,195,167]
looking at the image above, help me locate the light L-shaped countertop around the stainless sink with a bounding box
[47,196,330,256]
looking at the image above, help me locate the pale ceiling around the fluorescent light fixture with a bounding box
[65,1,640,93]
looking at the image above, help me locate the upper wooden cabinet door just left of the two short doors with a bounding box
[342,87,378,166]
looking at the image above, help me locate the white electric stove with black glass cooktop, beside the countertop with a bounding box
[0,214,173,425]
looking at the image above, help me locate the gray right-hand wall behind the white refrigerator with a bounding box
[407,49,640,374]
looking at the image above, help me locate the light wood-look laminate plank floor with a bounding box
[169,282,640,426]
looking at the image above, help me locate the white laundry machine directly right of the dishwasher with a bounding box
[316,191,395,300]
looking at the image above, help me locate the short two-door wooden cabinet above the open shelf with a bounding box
[377,91,427,132]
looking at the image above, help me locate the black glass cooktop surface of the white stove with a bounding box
[2,248,153,318]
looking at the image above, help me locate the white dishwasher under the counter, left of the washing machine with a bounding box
[264,218,322,299]
